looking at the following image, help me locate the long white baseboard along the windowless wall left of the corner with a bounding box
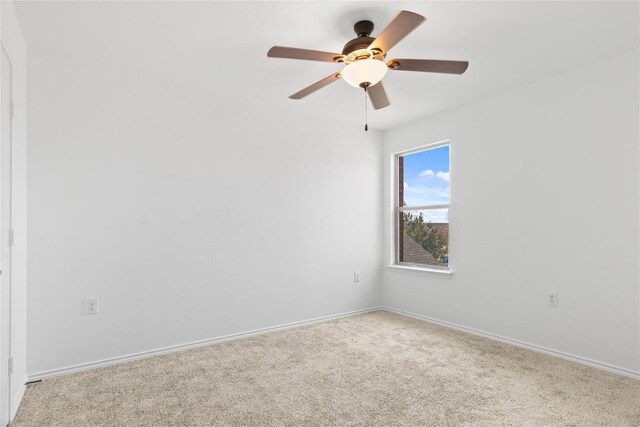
[23,307,382,382]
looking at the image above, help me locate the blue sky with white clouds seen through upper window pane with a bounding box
[404,146,449,217]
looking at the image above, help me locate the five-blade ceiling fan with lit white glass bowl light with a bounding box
[267,10,469,116]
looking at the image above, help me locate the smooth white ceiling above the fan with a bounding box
[16,1,639,129]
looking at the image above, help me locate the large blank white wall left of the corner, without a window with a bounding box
[28,50,382,374]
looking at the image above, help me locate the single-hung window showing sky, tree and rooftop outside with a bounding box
[395,143,450,271]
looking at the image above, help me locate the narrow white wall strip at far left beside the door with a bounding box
[0,1,27,418]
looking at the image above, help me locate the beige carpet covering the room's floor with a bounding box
[12,312,640,427]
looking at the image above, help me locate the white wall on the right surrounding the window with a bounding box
[383,52,640,373]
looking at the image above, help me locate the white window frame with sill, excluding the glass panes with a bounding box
[388,139,453,278]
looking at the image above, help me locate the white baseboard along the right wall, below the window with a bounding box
[381,306,640,380]
